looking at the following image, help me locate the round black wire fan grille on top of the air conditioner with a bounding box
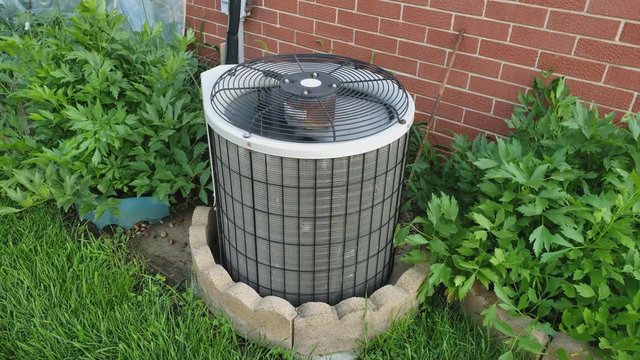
[211,54,409,142]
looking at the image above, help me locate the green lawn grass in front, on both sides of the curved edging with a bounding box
[0,206,520,360]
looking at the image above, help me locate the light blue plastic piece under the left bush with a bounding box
[80,196,169,229]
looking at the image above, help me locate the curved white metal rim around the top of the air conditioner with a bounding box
[201,65,415,159]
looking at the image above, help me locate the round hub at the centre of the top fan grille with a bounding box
[280,72,341,98]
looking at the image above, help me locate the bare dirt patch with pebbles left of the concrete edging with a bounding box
[129,209,193,288]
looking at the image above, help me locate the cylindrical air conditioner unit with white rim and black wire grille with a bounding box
[202,54,415,305]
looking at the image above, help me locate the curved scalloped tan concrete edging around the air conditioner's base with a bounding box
[189,206,429,356]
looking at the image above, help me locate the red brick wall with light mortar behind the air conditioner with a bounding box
[187,0,640,144]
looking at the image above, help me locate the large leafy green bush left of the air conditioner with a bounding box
[0,0,210,217]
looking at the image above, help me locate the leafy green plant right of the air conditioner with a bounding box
[396,78,640,359]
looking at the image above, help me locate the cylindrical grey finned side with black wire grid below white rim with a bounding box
[209,129,407,306]
